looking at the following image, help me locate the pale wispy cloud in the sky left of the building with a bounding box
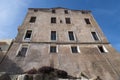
[0,0,29,38]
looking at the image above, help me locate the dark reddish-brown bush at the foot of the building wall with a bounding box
[25,66,71,80]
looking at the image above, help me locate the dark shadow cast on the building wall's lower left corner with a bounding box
[0,54,23,74]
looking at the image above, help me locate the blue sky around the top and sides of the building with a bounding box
[0,0,120,51]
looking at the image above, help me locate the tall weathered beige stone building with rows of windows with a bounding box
[0,7,120,80]
